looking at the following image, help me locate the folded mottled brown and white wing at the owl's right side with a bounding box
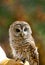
[30,36,39,65]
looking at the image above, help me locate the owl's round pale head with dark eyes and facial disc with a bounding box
[10,21,32,37]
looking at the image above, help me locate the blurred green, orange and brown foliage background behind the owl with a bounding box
[0,0,45,65]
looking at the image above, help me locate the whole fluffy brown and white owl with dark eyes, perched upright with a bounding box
[9,21,39,65]
